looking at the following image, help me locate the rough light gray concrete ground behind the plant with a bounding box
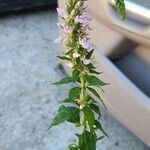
[0,9,148,150]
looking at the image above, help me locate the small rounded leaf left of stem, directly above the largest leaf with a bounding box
[69,87,81,99]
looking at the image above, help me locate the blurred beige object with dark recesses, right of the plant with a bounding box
[59,0,150,146]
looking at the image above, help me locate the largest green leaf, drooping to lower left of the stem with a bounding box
[49,106,80,129]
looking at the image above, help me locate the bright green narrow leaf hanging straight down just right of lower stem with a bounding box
[83,106,94,132]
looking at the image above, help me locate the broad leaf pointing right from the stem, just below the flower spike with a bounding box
[85,75,108,86]
